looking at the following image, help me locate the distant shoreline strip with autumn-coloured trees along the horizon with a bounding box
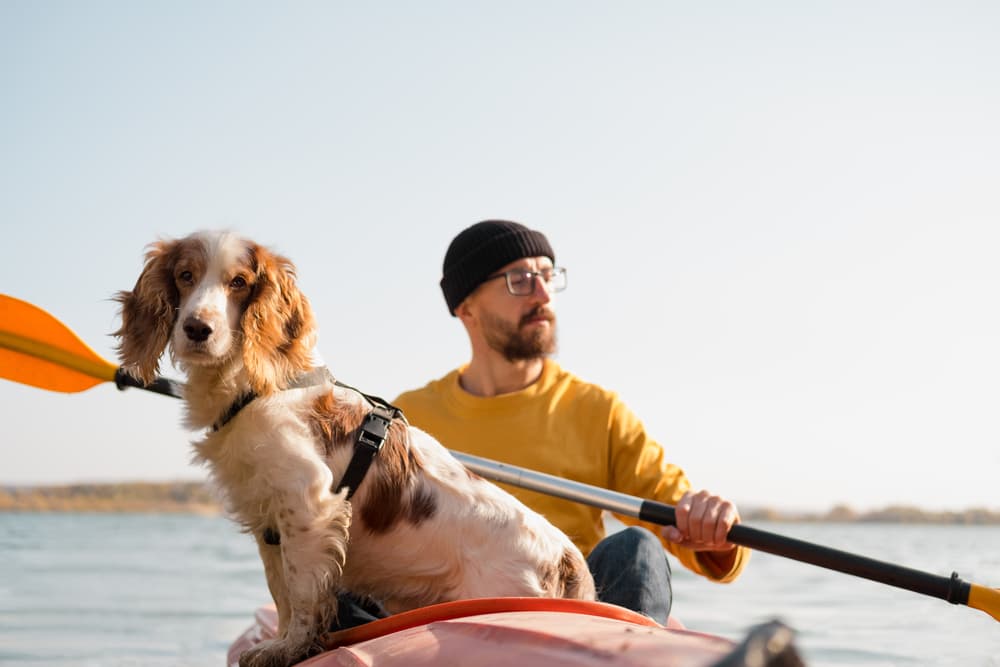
[0,481,1000,526]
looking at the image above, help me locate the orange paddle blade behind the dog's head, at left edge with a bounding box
[0,294,118,393]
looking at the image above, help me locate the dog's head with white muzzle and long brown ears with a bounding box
[114,232,315,394]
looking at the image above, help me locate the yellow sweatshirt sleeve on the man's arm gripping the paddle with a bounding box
[608,397,750,583]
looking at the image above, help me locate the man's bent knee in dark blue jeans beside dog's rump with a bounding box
[587,526,673,625]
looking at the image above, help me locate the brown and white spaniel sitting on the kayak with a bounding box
[115,232,594,665]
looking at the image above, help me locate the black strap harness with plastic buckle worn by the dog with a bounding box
[212,366,405,546]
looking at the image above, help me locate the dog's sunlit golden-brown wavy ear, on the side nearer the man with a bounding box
[243,245,316,395]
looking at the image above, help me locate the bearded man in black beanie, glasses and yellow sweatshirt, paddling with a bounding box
[394,220,749,623]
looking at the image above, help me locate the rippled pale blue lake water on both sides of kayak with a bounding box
[0,513,1000,667]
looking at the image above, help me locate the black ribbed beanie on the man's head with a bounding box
[441,220,556,315]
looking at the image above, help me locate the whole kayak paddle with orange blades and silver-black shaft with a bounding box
[0,294,1000,621]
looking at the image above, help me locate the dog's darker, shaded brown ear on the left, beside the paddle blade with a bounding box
[113,240,180,384]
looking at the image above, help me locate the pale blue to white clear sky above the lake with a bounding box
[0,0,1000,510]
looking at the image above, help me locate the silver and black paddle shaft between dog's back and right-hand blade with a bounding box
[451,451,971,604]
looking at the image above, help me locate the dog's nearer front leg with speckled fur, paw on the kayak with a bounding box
[240,489,351,667]
